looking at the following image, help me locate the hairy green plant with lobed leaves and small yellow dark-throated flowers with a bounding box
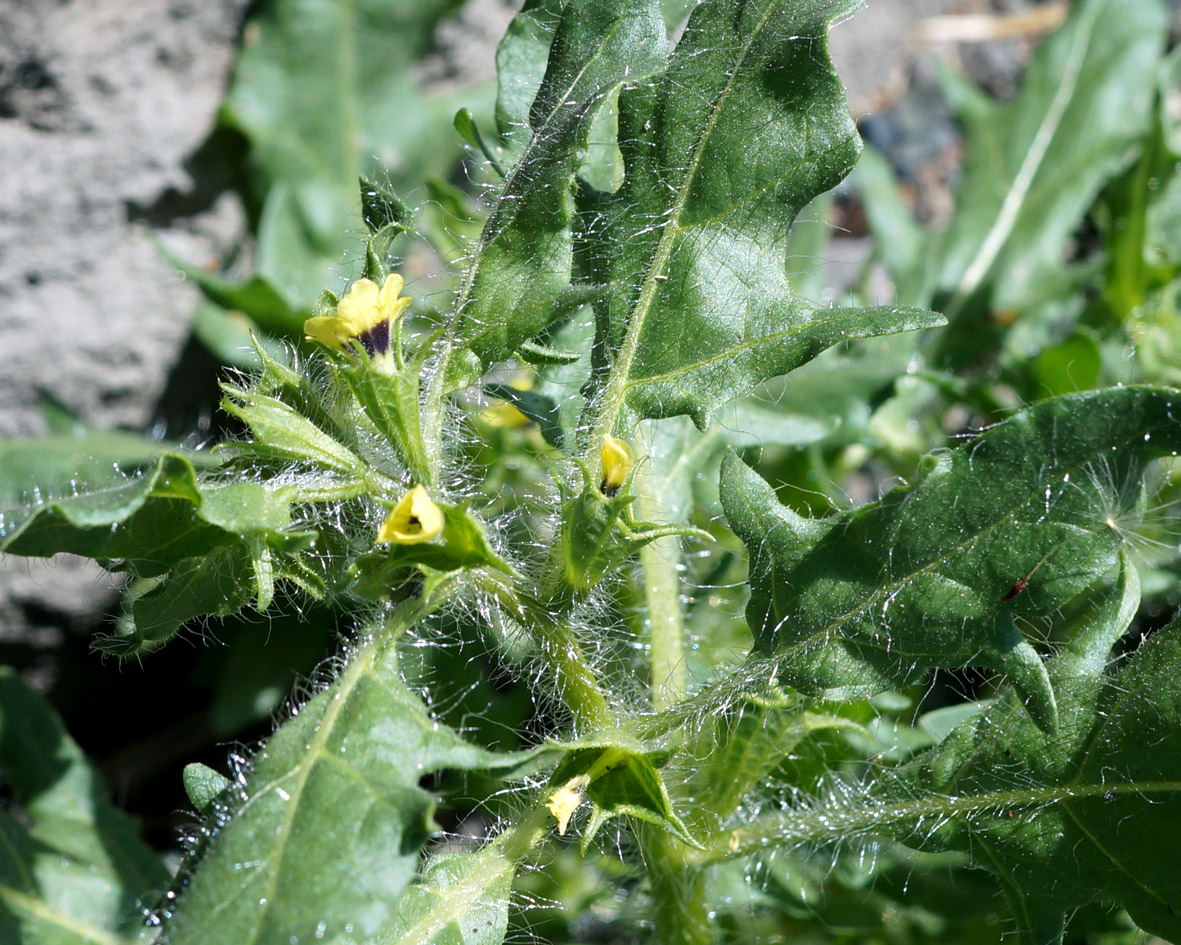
[0,0,1181,945]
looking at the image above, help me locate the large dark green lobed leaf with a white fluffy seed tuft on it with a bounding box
[722,387,1181,726]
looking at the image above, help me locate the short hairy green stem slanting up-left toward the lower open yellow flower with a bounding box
[482,574,615,731]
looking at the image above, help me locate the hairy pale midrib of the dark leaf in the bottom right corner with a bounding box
[700,781,1181,863]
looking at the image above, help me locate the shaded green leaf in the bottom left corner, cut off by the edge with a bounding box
[0,667,168,945]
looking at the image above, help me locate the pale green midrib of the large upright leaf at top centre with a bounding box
[583,4,777,460]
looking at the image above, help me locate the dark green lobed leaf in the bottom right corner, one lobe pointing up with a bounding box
[859,557,1181,945]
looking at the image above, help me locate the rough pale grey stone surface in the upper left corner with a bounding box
[0,0,246,436]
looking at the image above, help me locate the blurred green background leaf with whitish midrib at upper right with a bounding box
[919,0,1168,326]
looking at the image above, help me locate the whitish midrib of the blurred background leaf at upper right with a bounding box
[946,0,1098,321]
